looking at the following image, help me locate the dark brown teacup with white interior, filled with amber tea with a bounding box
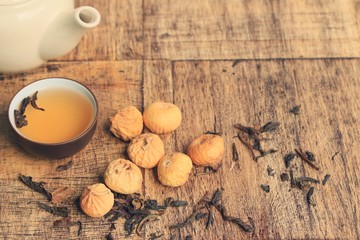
[8,78,98,158]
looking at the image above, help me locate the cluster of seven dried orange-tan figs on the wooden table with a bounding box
[80,102,225,217]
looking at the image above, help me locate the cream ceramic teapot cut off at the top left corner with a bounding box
[0,0,101,72]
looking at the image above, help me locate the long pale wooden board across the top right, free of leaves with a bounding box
[144,0,360,60]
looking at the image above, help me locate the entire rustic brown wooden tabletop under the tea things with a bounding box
[0,0,360,239]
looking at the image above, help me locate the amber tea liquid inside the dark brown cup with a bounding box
[19,88,94,143]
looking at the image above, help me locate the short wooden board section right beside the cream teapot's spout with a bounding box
[55,0,143,61]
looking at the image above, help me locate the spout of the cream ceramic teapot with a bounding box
[40,6,101,60]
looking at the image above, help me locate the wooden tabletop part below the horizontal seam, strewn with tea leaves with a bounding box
[0,60,360,239]
